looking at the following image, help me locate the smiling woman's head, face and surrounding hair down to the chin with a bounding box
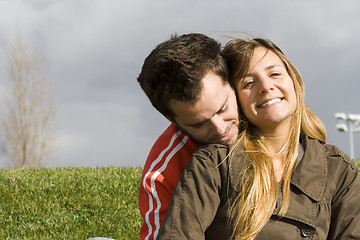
[222,39,304,134]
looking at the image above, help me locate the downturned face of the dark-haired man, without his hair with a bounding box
[169,73,239,144]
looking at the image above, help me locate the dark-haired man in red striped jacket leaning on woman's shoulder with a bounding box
[138,34,239,239]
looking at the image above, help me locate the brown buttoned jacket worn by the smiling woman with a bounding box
[158,137,360,240]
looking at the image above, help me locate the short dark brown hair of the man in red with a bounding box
[137,33,228,119]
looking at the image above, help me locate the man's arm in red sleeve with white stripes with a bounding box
[139,125,197,240]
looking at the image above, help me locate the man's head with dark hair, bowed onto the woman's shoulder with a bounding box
[138,34,238,144]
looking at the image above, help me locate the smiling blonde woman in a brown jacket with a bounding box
[159,39,360,239]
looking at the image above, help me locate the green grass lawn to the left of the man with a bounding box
[0,167,142,240]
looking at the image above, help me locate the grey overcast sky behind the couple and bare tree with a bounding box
[0,0,360,169]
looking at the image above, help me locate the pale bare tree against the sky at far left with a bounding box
[0,34,55,168]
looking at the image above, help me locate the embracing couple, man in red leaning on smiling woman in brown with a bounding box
[138,34,360,239]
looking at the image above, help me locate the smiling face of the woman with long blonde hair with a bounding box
[236,47,296,134]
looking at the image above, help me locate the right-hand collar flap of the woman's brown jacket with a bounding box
[290,135,327,201]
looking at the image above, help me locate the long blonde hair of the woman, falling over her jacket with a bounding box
[222,38,326,240]
